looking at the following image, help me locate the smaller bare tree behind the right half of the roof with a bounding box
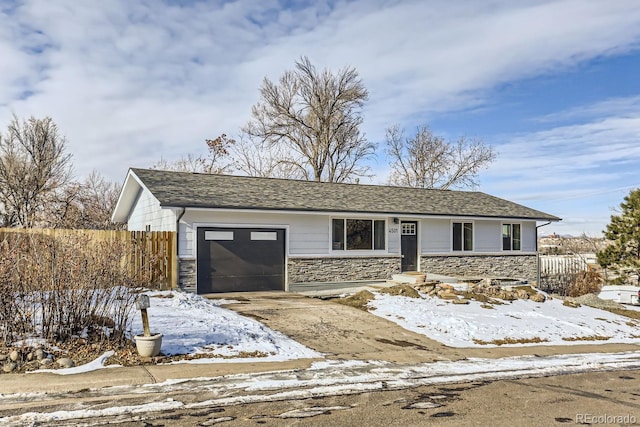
[386,126,496,189]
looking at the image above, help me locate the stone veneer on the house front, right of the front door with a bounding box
[420,254,538,282]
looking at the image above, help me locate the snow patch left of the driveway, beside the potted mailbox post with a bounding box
[132,291,322,363]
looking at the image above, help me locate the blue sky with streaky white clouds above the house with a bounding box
[0,0,640,237]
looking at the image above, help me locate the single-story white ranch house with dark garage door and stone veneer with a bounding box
[112,169,560,293]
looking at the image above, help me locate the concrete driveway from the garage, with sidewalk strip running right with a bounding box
[210,292,638,363]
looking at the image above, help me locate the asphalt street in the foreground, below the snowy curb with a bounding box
[0,370,640,427]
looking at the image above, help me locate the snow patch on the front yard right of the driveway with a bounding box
[369,294,640,347]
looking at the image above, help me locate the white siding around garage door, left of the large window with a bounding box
[179,210,331,257]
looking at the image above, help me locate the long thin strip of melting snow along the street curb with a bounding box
[7,352,640,426]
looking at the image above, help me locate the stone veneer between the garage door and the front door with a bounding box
[287,256,401,283]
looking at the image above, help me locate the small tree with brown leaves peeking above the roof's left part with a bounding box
[151,133,236,174]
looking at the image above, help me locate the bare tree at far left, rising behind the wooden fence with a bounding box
[0,116,71,227]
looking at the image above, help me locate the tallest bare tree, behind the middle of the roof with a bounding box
[242,57,375,182]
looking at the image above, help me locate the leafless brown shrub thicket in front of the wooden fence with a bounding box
[0,233,158,345]
